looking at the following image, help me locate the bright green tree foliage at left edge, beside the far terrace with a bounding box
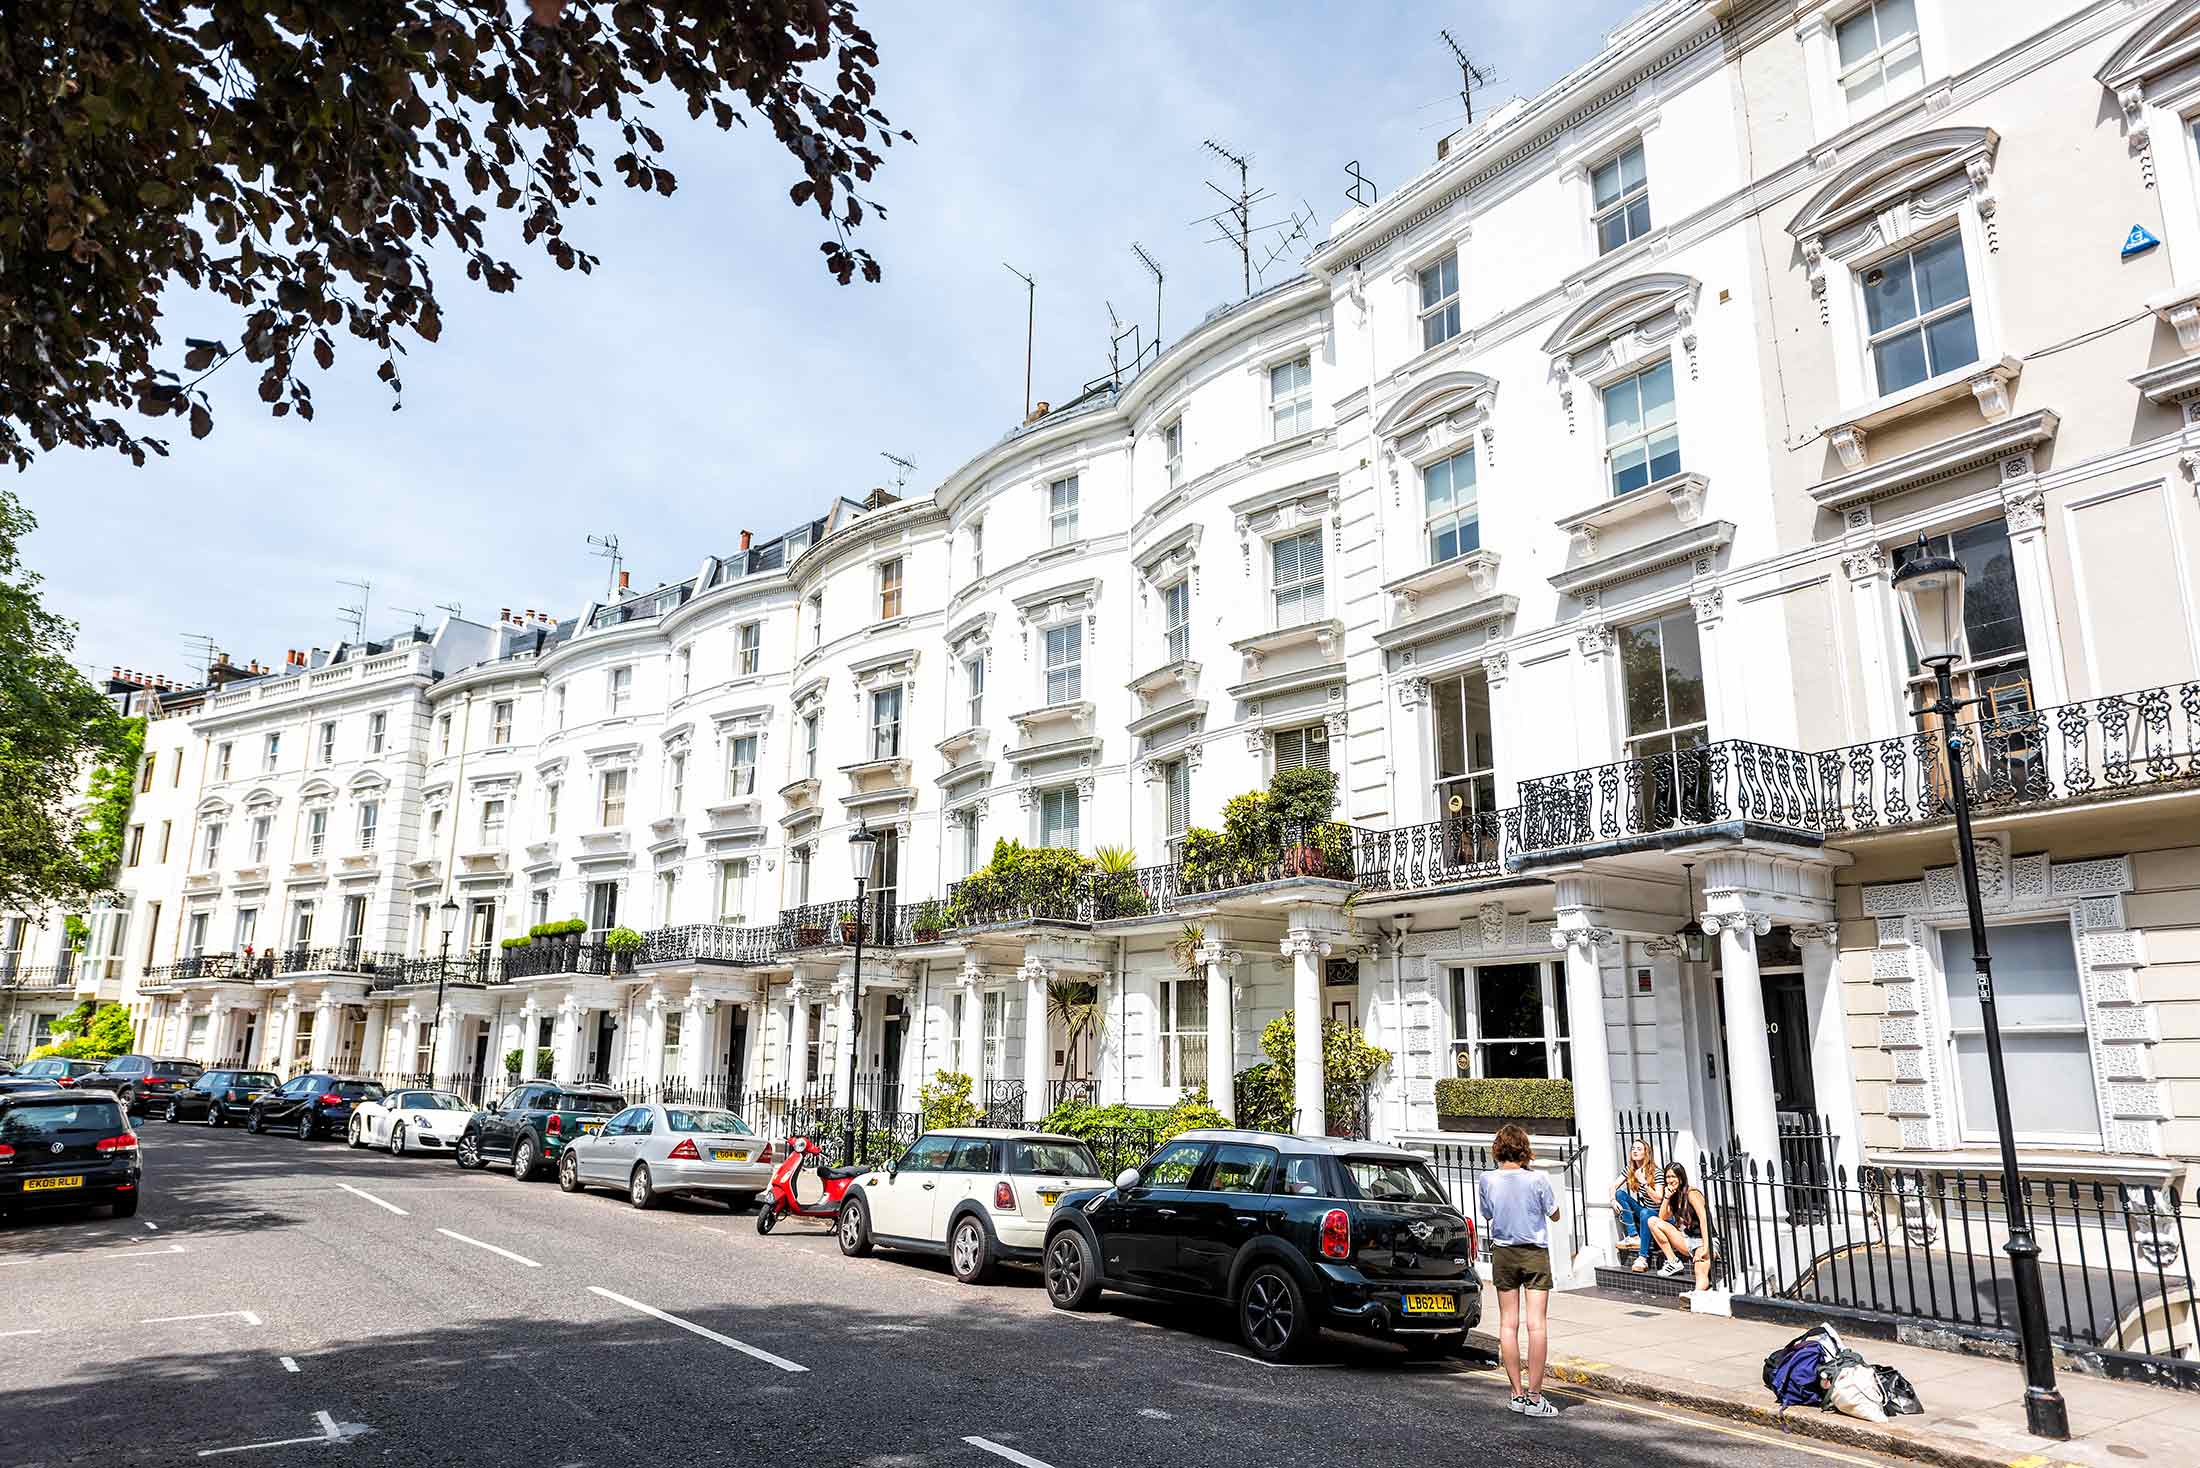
[0,488,143,911]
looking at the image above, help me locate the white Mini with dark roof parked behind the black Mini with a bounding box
[840,1127,1107,1285]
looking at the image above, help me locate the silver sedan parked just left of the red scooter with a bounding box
[557,1103,774,1208]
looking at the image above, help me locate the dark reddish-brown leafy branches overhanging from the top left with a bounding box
[0,0,909,467]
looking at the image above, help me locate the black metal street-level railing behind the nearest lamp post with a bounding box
[1703,1158,2200,1362]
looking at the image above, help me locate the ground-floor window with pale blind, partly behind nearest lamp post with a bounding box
[1940,920,2101,1144]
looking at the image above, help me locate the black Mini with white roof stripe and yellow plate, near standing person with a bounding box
[1043,1131,1483,1360]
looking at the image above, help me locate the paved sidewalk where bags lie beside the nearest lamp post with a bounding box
[1474,1292,2200,1468]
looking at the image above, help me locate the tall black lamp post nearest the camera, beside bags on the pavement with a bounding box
[1894,535,2070,1437]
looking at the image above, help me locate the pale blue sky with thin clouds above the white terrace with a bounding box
[25,0,1646,678]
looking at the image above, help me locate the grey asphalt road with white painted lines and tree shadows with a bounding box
[0,1120,1909,1468]
